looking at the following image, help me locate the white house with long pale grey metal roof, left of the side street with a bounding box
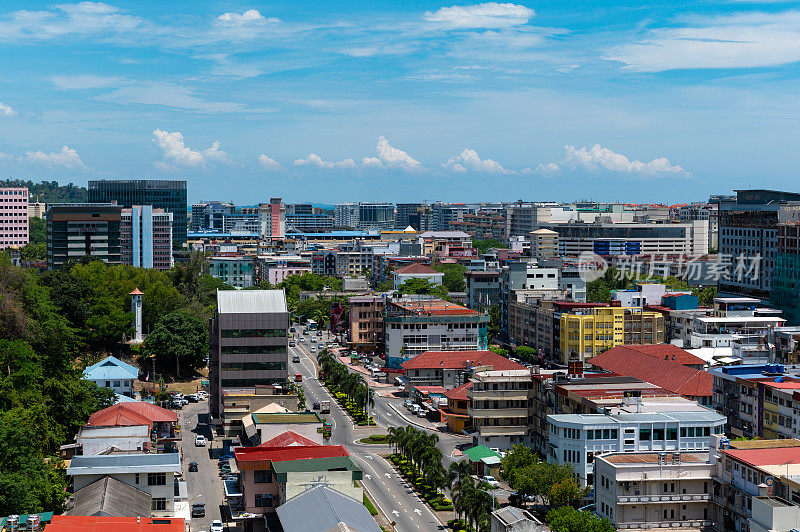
[67,453,185,517]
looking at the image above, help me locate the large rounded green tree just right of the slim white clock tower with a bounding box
[142,312,208,376]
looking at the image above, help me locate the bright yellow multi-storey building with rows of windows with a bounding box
[559,307,664,364]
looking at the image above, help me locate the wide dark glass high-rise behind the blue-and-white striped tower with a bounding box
[89,179,188,248]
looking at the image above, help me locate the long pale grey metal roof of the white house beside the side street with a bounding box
[67,453,181,476]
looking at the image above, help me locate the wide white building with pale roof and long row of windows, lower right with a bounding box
[547,405,726,486]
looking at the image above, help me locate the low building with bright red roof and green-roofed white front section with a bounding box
[234,445,363,515]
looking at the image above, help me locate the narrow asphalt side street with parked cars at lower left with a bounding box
[179,400,222,531]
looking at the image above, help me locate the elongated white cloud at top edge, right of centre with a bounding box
[425,2,535,29]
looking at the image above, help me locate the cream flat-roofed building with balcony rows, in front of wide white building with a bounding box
[594,452,715,532]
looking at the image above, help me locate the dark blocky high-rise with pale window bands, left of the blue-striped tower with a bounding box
[46,203,122,270]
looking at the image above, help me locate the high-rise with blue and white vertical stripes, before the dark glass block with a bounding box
[120,205,173,271]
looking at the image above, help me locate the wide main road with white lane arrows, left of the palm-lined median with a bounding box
[289,343,445,532]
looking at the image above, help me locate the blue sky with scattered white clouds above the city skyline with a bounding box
[0,0,800,203]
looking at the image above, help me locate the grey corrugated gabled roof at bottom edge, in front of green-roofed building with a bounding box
[276,486,381,532]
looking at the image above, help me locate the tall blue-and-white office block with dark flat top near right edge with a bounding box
[718,190,800,298]
